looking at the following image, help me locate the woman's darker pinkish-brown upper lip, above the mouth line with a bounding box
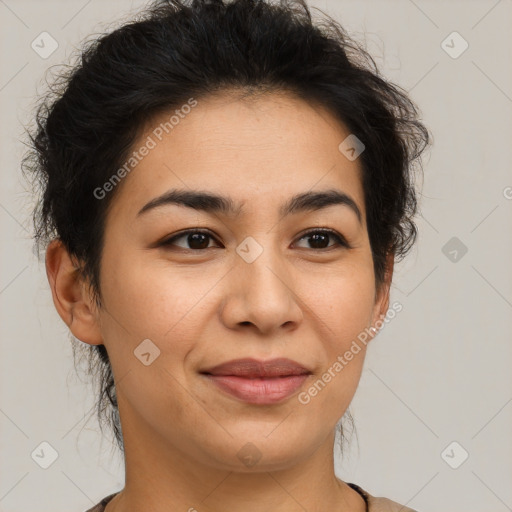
[200,358,311,378]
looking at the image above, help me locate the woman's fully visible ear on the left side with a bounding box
[46,239,103,345]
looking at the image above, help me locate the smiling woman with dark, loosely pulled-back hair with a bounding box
[25,0,429,512]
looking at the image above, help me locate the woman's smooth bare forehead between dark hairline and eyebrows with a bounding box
[108,89,364,218]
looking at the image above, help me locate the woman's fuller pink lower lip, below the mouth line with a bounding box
[202,375,309,404]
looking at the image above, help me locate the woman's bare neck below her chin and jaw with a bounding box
[105,400,365,512]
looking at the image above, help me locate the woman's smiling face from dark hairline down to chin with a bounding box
[63,94,388,471]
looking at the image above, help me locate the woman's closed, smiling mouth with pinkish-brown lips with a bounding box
[200,358,312,405]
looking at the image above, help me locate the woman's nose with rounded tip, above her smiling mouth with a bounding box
[221,240,303,335]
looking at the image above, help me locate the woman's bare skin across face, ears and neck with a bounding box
[46,93,393,512]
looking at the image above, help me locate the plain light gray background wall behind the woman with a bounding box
[0,0,512,512]
